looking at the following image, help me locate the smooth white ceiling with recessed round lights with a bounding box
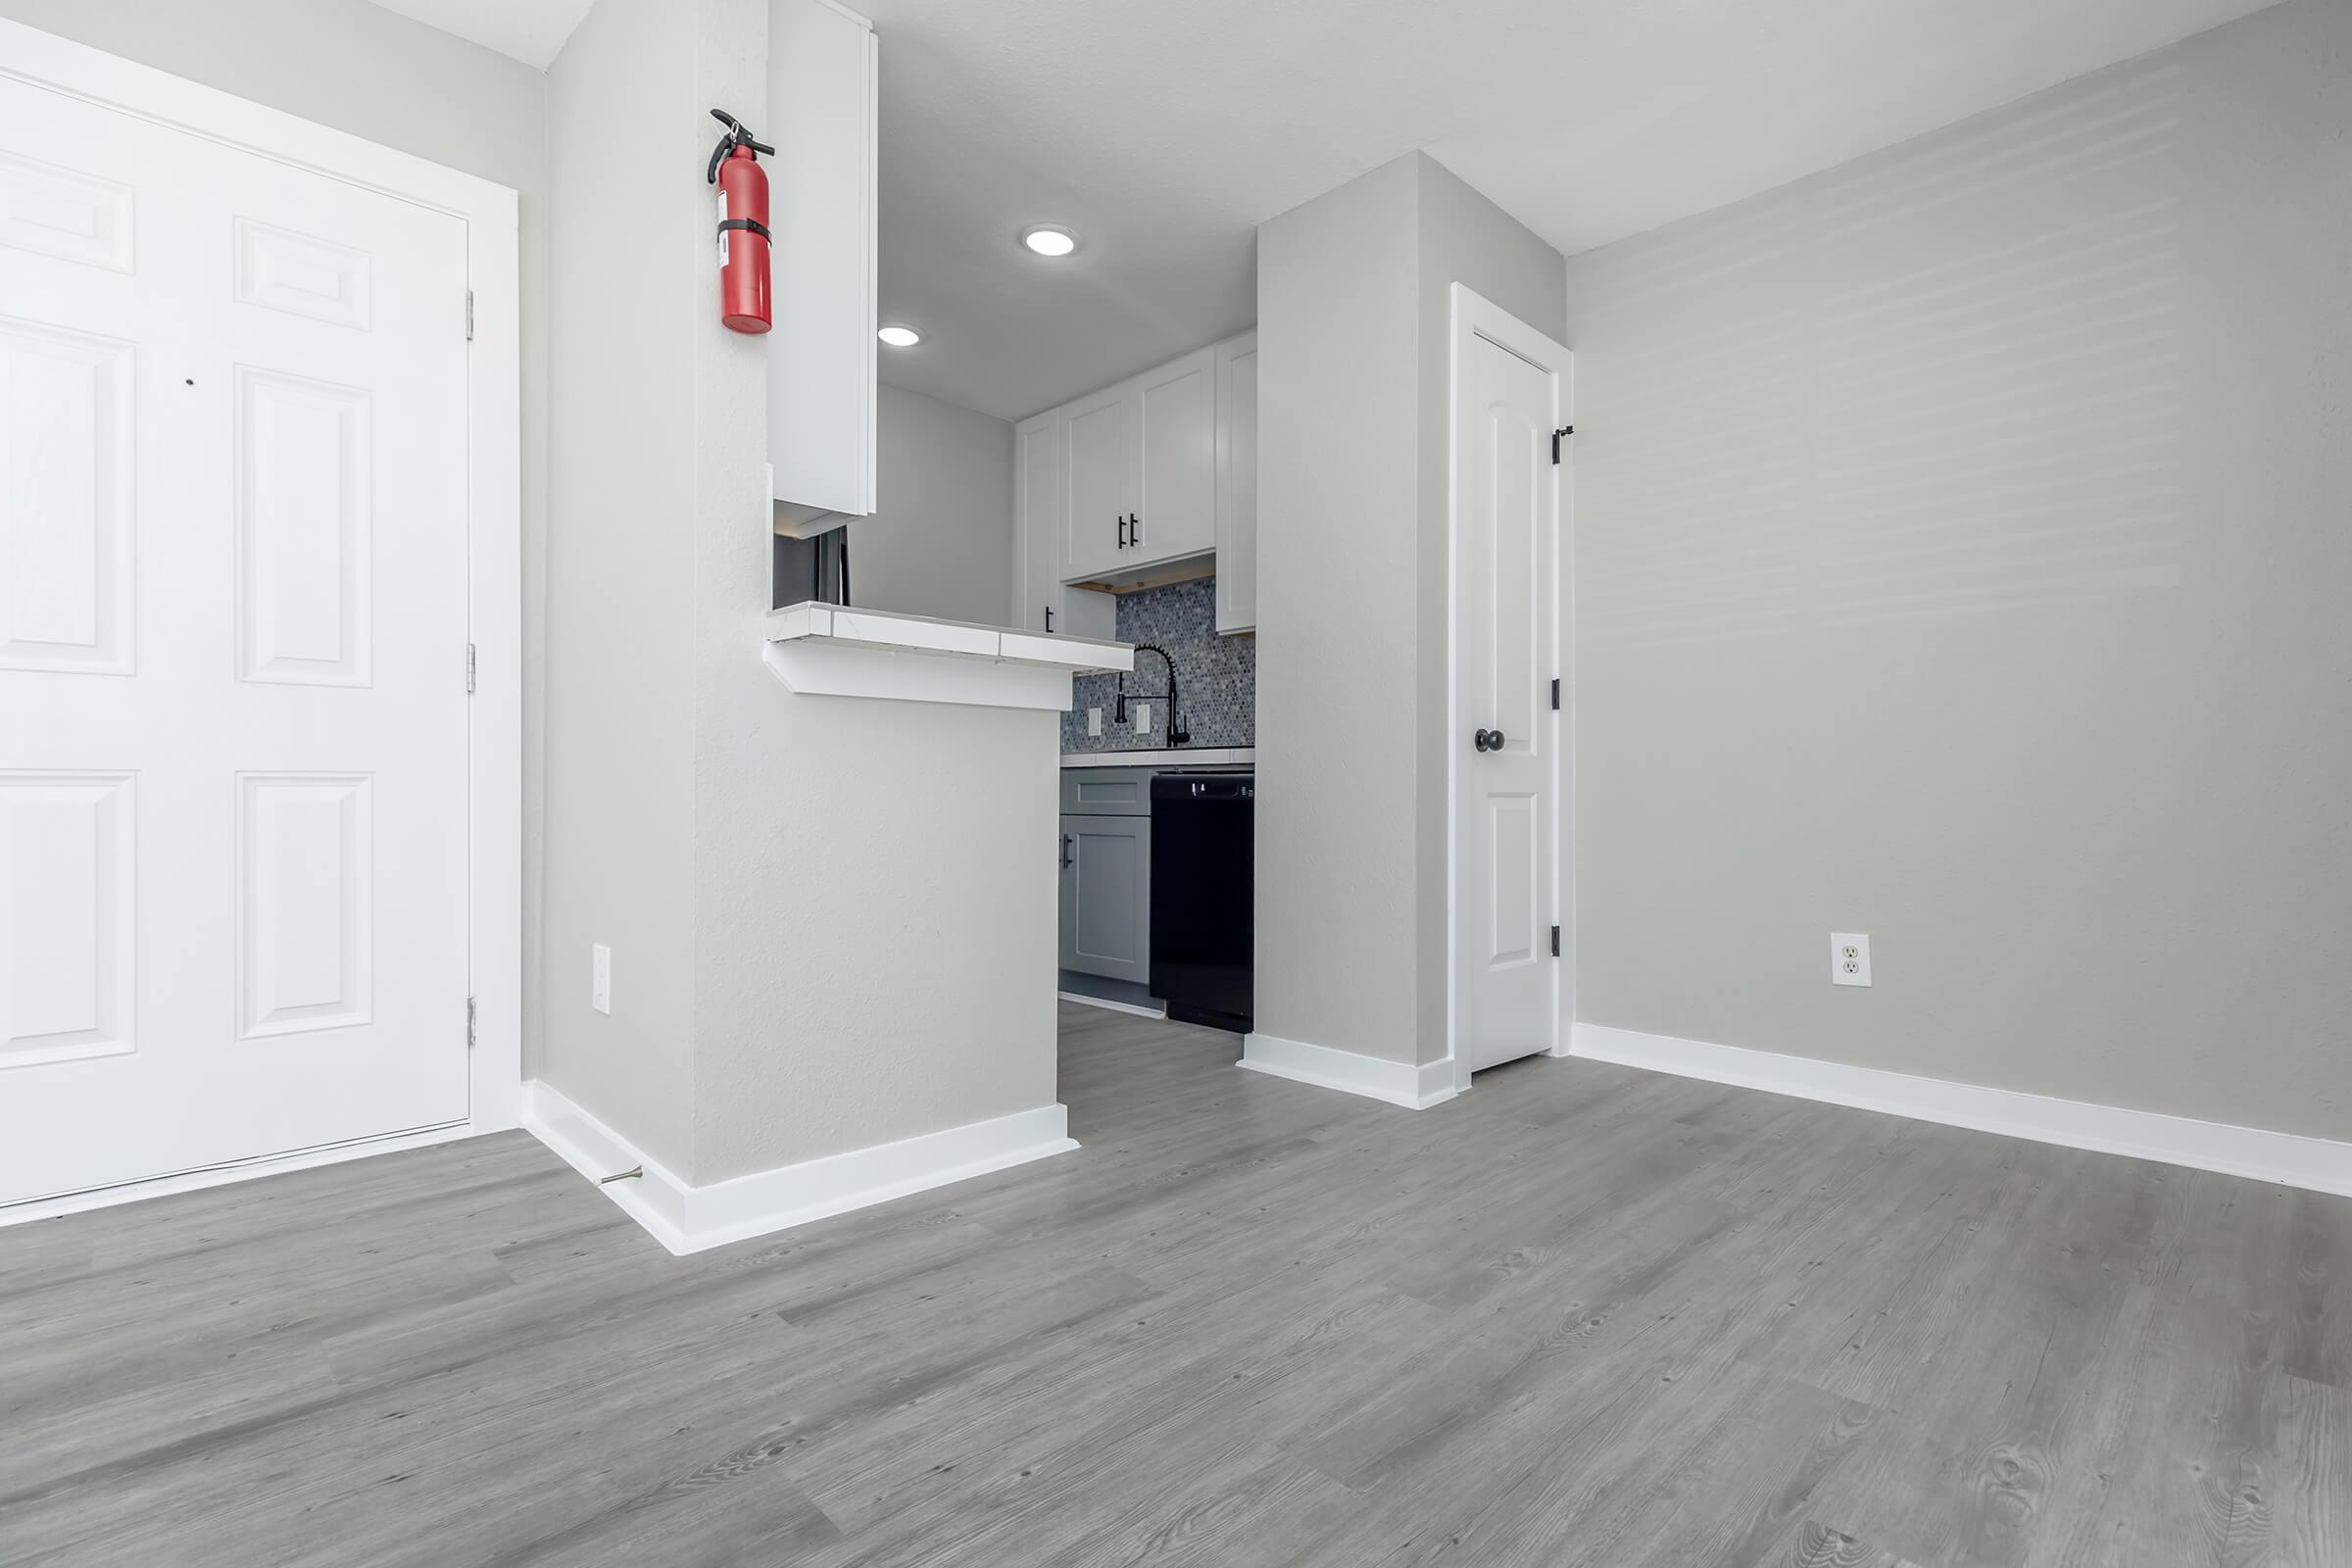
[386,0,2270,418]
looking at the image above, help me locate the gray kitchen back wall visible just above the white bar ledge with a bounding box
[849,385,1013,625]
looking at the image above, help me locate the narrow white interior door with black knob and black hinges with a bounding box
[1451,289,1566,1069]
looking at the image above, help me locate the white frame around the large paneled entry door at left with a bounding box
[0,19,522,1225]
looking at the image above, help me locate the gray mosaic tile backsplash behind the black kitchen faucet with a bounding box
[1060,578,1258,753]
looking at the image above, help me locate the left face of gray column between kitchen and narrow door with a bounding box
[1253,158,1421,1062]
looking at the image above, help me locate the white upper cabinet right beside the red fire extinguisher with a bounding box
[755,0,880,534]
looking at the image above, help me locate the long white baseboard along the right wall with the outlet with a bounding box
[1569,1022,2352,1197]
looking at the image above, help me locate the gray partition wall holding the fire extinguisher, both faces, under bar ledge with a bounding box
[543,0,1056,1185]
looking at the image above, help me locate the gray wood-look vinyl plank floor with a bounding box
[0,1006,2352,1568]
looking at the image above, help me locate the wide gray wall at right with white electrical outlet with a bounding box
[1561,0,2352,1138]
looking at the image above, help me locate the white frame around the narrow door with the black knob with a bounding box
[1445,282,1576,1093]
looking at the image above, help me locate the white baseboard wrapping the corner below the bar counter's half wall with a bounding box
[522,1081,1077,1255]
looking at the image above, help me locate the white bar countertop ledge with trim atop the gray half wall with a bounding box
[764,602,1136,712]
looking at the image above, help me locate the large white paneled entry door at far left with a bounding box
[0,82,468,1203]
